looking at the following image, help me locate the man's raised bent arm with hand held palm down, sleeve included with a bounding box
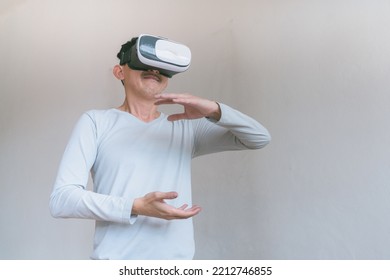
[156,93,271,156]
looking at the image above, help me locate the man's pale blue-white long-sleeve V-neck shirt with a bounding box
[50,104,270,259]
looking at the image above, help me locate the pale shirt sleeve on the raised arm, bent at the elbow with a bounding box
[193,103,271,157]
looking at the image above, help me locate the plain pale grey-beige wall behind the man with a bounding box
[0,0,390,259]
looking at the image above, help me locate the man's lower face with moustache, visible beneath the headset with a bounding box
[122,65,168,98]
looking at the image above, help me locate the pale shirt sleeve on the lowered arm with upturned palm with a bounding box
[49,113,135,224]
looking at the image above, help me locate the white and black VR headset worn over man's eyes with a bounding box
[117,34,191,78]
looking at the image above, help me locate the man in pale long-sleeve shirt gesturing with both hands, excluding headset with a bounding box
[50,35,270,259]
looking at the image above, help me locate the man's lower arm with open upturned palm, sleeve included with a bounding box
[49,113,201,223]
